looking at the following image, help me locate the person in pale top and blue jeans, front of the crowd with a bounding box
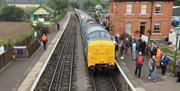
[149,55,157,82]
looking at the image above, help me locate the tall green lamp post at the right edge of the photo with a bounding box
[173,27,180,75]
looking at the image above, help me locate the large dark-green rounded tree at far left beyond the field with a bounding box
[0,6,25,21]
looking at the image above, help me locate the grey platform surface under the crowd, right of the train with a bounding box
[117,51,180,91]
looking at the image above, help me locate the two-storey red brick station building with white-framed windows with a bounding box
[109,0,173,39]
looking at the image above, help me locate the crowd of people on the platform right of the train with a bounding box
[114,35,180,82]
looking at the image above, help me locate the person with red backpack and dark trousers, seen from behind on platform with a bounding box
[135,52,144,78]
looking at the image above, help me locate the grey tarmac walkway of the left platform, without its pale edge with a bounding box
[0,31,57,91]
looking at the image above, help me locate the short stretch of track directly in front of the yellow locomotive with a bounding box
[90,73,121,91]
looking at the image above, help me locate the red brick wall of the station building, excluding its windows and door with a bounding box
[110,2,173,39]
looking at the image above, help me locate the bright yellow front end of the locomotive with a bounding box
[87,40,115,69]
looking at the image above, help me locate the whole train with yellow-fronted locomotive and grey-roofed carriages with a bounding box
[75,9,116,71]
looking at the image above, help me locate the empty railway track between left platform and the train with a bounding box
[35,15,77,91]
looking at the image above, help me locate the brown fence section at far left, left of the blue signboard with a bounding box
[0,48,14,69]
